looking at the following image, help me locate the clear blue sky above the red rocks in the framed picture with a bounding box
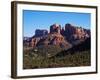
[23,10,91,37]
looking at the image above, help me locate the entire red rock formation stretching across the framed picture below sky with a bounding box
[23,24,91,49]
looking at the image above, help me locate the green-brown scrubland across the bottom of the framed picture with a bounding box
[23,46,91,69]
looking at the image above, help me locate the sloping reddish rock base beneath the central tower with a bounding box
[37,33,71,48]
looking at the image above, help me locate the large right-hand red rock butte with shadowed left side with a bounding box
[63,23,90,43]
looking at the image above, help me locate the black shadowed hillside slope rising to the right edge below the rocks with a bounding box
[55,38,91,57]
